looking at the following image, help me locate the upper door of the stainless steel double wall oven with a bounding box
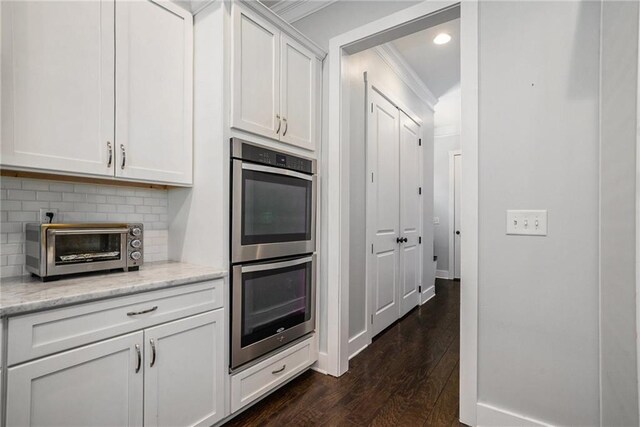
[231,159,316,263]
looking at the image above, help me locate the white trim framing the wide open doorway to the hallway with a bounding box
[320,0,478,425]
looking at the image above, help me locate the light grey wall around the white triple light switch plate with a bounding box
[478,1,601,425]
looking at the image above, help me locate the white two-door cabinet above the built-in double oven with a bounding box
[231,3,320,150]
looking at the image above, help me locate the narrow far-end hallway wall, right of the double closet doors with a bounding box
[433,86,460,272]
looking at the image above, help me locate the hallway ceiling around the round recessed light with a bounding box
[388,18,460,98]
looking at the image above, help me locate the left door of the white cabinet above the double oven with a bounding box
[231,4,282,139]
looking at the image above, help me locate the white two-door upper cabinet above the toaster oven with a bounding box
[0,0,193,185]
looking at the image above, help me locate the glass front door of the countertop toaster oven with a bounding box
[46,228,129,276]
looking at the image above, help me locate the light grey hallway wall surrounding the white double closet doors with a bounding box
[344,49,434,352]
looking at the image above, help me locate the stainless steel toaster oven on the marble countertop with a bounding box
[25,223,144,279]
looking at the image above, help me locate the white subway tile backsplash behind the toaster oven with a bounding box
[0,177,168,277]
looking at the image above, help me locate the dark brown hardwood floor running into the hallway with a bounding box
[226,279,460,426]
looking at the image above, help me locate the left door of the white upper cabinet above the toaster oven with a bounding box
[0,0,114,176]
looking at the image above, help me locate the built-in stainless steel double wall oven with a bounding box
[230,138,316,369]
